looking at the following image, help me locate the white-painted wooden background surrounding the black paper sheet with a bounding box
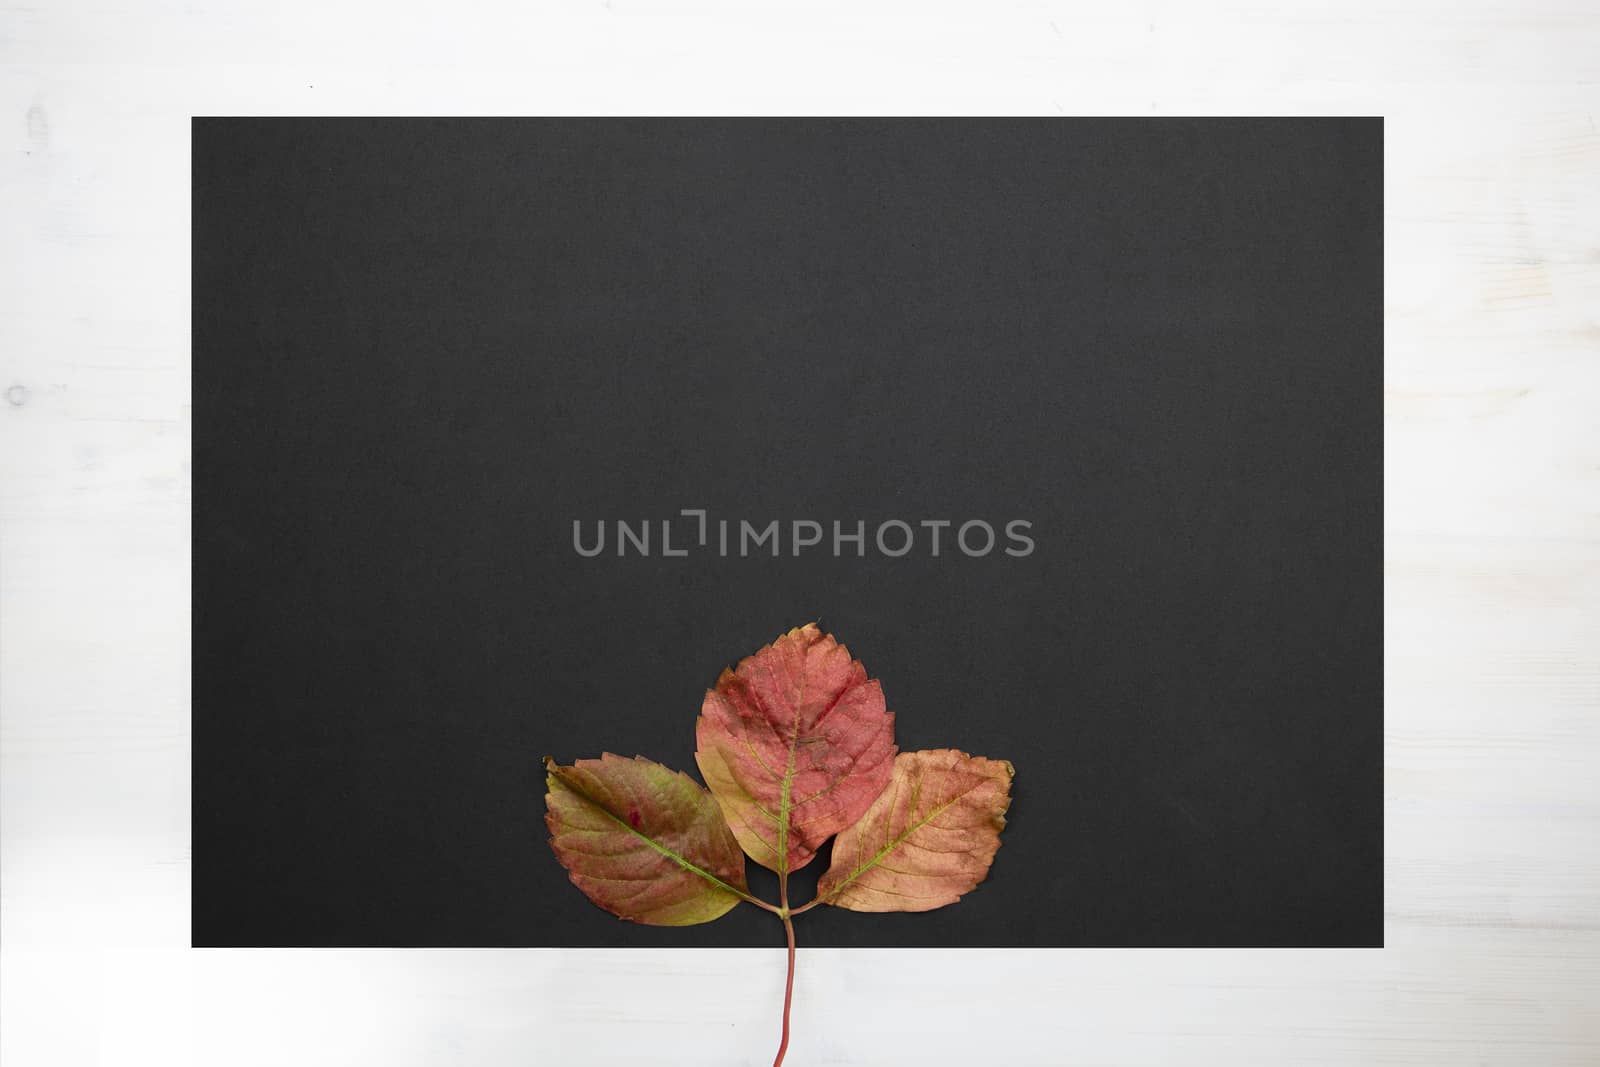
[0,0,1600,1067]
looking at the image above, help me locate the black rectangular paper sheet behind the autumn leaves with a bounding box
[194,120,1382,947]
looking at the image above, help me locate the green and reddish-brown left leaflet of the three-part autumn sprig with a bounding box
[544,752,749,926]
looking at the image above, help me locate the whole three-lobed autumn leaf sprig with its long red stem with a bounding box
[544,625,1013,1067]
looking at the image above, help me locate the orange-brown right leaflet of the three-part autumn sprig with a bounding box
[816,749,1014,912]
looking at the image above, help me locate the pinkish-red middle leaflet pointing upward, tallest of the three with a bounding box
[694,624,894,873]
